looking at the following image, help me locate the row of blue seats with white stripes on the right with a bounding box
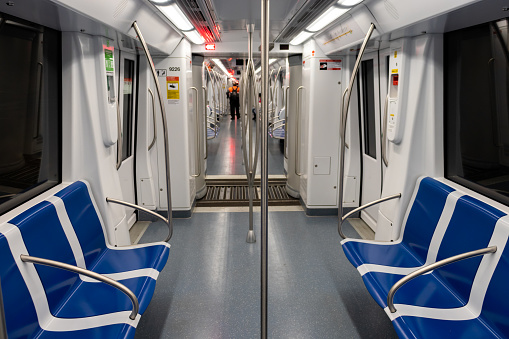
[343,178,509,338]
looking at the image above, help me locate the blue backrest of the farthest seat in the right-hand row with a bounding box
[402,177,454,263]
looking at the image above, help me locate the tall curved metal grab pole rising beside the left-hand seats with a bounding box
[132,21,173,241]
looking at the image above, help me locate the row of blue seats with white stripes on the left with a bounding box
[0,182,169,338]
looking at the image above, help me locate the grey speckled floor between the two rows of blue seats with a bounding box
[135,211,397,339]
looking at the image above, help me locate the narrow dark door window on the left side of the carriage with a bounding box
[122,59,134,160]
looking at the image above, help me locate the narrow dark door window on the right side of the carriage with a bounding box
[361,60,376,159]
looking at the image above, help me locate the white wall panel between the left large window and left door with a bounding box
[62,32,130,245]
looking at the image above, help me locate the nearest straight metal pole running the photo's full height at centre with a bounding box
[261,0,270,339]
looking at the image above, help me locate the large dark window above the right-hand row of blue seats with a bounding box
[445,19,509,204]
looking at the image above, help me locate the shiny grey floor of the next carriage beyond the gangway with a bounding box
[207,115,284,175]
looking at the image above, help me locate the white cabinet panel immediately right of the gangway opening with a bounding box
[300,40,343,208]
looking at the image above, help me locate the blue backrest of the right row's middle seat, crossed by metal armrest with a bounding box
[435,195,506,303]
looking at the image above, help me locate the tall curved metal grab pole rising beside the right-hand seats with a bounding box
[338,23,375,235]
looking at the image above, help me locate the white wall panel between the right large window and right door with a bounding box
[376,34,444,240]
